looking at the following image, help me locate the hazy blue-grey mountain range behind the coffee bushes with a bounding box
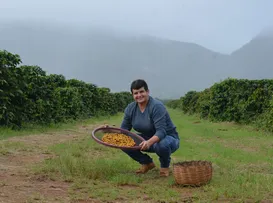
[0,22,273,99]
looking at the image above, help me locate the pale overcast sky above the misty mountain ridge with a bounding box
[0,0,273,53]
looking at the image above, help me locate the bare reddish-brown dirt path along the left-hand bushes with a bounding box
[0,126,94,203]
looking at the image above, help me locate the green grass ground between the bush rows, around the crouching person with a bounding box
[0,110,273,202]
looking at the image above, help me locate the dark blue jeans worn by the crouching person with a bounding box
[122,136,180,168]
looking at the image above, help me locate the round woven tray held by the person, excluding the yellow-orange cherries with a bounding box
[92,127,145,150]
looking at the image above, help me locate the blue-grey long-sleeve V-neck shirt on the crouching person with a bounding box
[121,96,179,140]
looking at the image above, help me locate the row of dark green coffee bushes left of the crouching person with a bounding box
[0,51,132,128]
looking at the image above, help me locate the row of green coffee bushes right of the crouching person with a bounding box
[167,78,273,131]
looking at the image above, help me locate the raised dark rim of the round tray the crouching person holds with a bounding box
[92,126,145,150]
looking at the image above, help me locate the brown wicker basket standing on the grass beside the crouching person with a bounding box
[173,161,213,186]
